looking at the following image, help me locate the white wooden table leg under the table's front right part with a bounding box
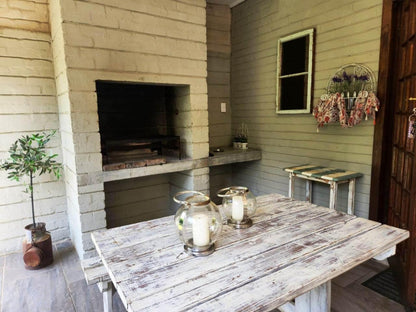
[295,281,331,312]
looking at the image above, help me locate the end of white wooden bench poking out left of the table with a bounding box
[81,257,113,312]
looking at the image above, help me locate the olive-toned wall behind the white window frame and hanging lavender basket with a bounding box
[231,0,383,217]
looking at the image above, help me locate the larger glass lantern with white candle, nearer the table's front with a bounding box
[173,191,222,257]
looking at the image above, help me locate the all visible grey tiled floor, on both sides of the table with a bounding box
[0,240,405,312]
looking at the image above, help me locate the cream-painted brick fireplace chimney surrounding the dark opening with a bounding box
[50,0,209,258]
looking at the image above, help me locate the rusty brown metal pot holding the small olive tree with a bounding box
[23,222,53,270]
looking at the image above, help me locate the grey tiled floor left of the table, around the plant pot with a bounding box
[0,240,125,312]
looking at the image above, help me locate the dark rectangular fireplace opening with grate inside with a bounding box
[96,80,189,171]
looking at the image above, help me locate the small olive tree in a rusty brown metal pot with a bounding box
[0,131,62,269]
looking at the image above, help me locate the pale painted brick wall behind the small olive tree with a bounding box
[0,0,69,255]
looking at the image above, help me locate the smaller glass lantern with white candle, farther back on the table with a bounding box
[217,186,257,229]
